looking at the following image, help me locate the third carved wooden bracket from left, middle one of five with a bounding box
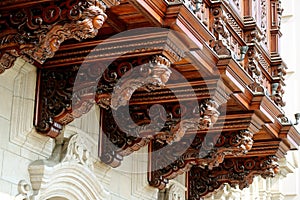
[99,100,219,167]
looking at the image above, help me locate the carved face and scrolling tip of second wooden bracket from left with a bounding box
[110,56,171,110]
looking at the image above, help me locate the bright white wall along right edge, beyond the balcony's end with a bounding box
[280,0,300,200]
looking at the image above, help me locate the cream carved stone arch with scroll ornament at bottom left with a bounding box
[25,134,110,200]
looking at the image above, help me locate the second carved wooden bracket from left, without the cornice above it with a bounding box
[35,56,171,137]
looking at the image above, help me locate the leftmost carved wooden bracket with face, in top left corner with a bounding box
[0,0,107,71]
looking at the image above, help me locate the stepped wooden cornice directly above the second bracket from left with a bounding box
[43,27,188,68]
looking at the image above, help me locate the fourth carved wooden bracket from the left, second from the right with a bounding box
[148,130,253,189]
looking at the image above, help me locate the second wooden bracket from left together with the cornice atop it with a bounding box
[35,25,188,137]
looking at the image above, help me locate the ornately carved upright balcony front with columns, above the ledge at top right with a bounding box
[166,0,286,106]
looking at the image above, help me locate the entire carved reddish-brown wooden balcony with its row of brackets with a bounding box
[0,0,300,199]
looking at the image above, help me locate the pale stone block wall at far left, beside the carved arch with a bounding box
[0,59,52,199]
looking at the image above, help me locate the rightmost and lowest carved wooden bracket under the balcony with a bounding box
[187,156,279,200]
